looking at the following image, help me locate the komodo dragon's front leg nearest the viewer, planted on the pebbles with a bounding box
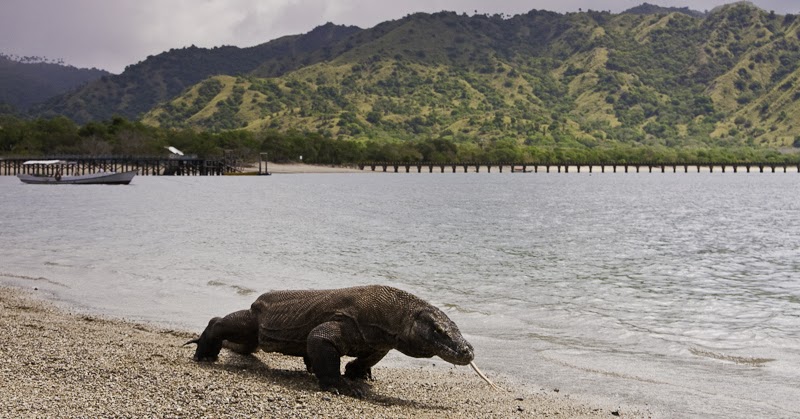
[306,321,365,398]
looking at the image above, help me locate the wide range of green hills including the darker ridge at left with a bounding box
[28,2,800,147]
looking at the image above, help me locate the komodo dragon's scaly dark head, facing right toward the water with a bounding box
[397,306,475,365]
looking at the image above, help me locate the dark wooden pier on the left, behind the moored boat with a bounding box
[0,156,235,176]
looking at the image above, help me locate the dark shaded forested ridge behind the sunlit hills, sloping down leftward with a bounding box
[28,24,360,123]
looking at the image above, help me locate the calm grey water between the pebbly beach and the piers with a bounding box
[0,173,800,417]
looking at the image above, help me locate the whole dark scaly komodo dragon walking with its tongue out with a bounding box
[186,285,496,397]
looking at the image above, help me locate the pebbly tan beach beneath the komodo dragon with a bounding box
[0,286,652,418]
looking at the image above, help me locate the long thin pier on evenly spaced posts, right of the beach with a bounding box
[358,162,800,173]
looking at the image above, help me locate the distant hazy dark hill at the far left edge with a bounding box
[0,54,110,111]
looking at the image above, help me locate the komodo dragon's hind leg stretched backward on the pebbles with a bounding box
[187,310,258,362]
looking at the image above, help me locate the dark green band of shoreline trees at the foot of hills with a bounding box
[0,115,800,165]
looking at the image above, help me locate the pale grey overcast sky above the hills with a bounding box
[0,0,800,73]
